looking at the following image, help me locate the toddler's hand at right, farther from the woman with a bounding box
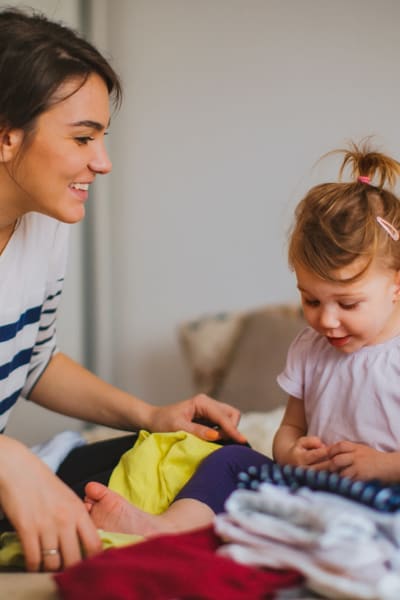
[328,441,398,481]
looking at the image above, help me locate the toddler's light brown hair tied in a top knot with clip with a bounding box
[289,140,400,282]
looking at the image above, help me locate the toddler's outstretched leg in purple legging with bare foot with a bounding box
[86,445,270,537]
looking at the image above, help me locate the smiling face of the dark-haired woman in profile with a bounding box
[7,74,111,223]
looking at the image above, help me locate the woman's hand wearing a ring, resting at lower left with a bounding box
[0,436,102,571]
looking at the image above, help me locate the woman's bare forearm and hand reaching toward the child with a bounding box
[30,353,245,442]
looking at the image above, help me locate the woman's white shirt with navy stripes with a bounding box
[0,213,69,433]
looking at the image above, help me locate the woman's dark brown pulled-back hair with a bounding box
[0,8,122,133]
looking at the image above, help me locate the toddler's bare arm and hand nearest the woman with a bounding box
[272,396,329,469]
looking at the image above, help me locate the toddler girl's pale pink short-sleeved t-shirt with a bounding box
[277,327,400,452]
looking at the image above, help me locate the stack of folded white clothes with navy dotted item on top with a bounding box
[215,465,400,600]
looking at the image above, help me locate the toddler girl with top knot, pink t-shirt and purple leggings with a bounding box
[86,144,400,535]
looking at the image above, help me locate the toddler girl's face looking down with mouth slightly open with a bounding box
[295,259,400,354]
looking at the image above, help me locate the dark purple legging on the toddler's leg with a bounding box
[174,444,273,514]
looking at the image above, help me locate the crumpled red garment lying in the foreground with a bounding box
[54,527,303,600]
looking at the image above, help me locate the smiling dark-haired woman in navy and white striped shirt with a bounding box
[0,10,243,571]
